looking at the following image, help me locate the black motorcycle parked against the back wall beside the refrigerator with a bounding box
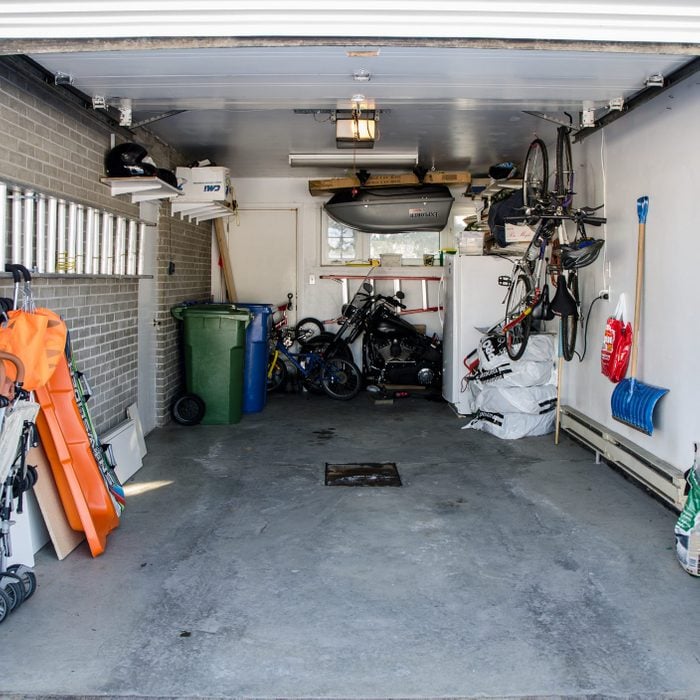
[296,282,442,393]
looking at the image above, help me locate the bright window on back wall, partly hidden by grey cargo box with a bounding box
[321,212,440,265]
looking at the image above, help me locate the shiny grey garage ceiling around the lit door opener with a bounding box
[23,46,688,177]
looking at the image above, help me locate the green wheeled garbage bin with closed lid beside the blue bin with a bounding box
[172,304,250,425]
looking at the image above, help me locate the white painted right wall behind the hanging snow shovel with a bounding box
[562,78,700,469]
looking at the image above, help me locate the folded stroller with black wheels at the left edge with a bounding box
[0,351,39,622]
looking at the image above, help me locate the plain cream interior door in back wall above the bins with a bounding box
[223,209,297,321]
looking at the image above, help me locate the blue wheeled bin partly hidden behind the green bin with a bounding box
[236,301,273,413]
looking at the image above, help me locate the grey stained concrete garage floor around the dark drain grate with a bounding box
[0,395,700,698]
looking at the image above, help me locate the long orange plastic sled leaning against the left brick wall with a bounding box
[34,355,119,557]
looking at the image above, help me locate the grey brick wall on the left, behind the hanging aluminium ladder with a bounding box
[0,57,211,432]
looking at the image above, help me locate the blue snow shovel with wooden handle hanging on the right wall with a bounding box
[610,196,668,435]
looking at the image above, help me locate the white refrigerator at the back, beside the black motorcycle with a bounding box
[442,255,513,415]
